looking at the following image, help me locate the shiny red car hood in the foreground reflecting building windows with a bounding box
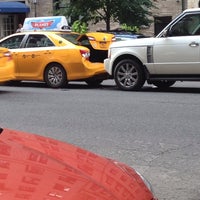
[0,129,156,200]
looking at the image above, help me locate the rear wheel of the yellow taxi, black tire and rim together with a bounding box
[45,63,67,88]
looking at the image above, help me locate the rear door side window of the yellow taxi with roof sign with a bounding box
[25,35,55,48]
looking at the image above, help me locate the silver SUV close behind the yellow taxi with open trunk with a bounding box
[104,8,200,90]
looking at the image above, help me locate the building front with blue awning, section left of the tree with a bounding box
[0,0,54,38]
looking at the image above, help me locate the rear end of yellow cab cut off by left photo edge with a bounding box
[0,47,15,82]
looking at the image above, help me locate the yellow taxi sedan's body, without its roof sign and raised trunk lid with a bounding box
[0,31,108,88]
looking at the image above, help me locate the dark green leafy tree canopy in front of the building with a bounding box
[56,0,155,31]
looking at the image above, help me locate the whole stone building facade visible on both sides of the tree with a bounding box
[0,0,200,37]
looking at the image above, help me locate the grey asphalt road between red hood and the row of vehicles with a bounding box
[0,81,200,200]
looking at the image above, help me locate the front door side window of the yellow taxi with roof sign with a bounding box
[0,35,24,49]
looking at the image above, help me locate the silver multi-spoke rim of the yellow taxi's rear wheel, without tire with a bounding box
[48,67,63,85]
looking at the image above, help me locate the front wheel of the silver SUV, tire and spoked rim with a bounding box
[114,59,145,91]
